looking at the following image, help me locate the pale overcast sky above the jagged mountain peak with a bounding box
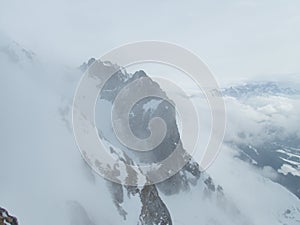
[0,0,300,85]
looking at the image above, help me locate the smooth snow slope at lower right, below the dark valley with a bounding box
[208,146,300,225]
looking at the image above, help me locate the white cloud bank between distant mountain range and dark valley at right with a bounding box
[225,92,300,144]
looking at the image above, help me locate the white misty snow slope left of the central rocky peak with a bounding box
[0,35,122,225]
